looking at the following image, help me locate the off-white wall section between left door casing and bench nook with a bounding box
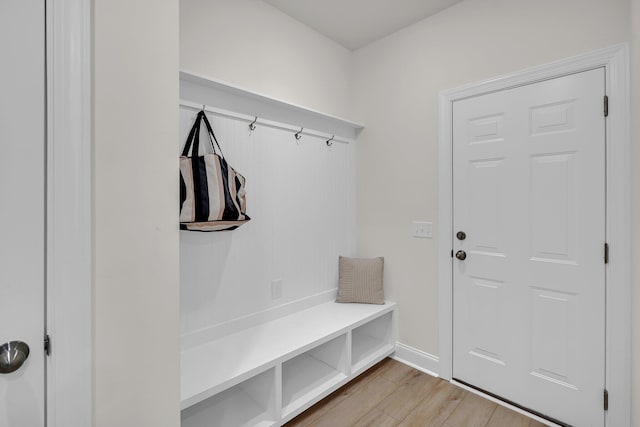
[92,0,180,427]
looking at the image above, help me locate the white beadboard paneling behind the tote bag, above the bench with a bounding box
[180,108,355,335]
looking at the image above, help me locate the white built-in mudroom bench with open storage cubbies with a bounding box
[180,302,396,427]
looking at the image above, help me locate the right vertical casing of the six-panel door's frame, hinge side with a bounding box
[606,45,631,427]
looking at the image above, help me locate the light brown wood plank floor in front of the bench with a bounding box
[285,359,544,427]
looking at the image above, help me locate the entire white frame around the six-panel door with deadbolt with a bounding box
[438,44,631,426]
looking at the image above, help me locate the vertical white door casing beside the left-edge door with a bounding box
[46,0,93,427]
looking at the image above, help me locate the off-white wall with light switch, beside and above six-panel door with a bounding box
[352,0,629,362]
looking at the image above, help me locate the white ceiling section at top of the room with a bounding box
[264,0,462,50]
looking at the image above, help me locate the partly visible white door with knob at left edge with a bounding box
[0,0,45,427]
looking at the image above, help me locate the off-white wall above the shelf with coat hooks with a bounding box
[180,0,350,116]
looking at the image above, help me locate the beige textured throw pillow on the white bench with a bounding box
[336,256,384,304]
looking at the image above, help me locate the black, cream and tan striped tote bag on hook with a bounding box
[180,111,250,231]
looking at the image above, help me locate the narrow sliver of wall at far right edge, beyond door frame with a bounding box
[629,0,640,427]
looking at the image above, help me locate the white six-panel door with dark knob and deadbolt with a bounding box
[452,68,606,427]
